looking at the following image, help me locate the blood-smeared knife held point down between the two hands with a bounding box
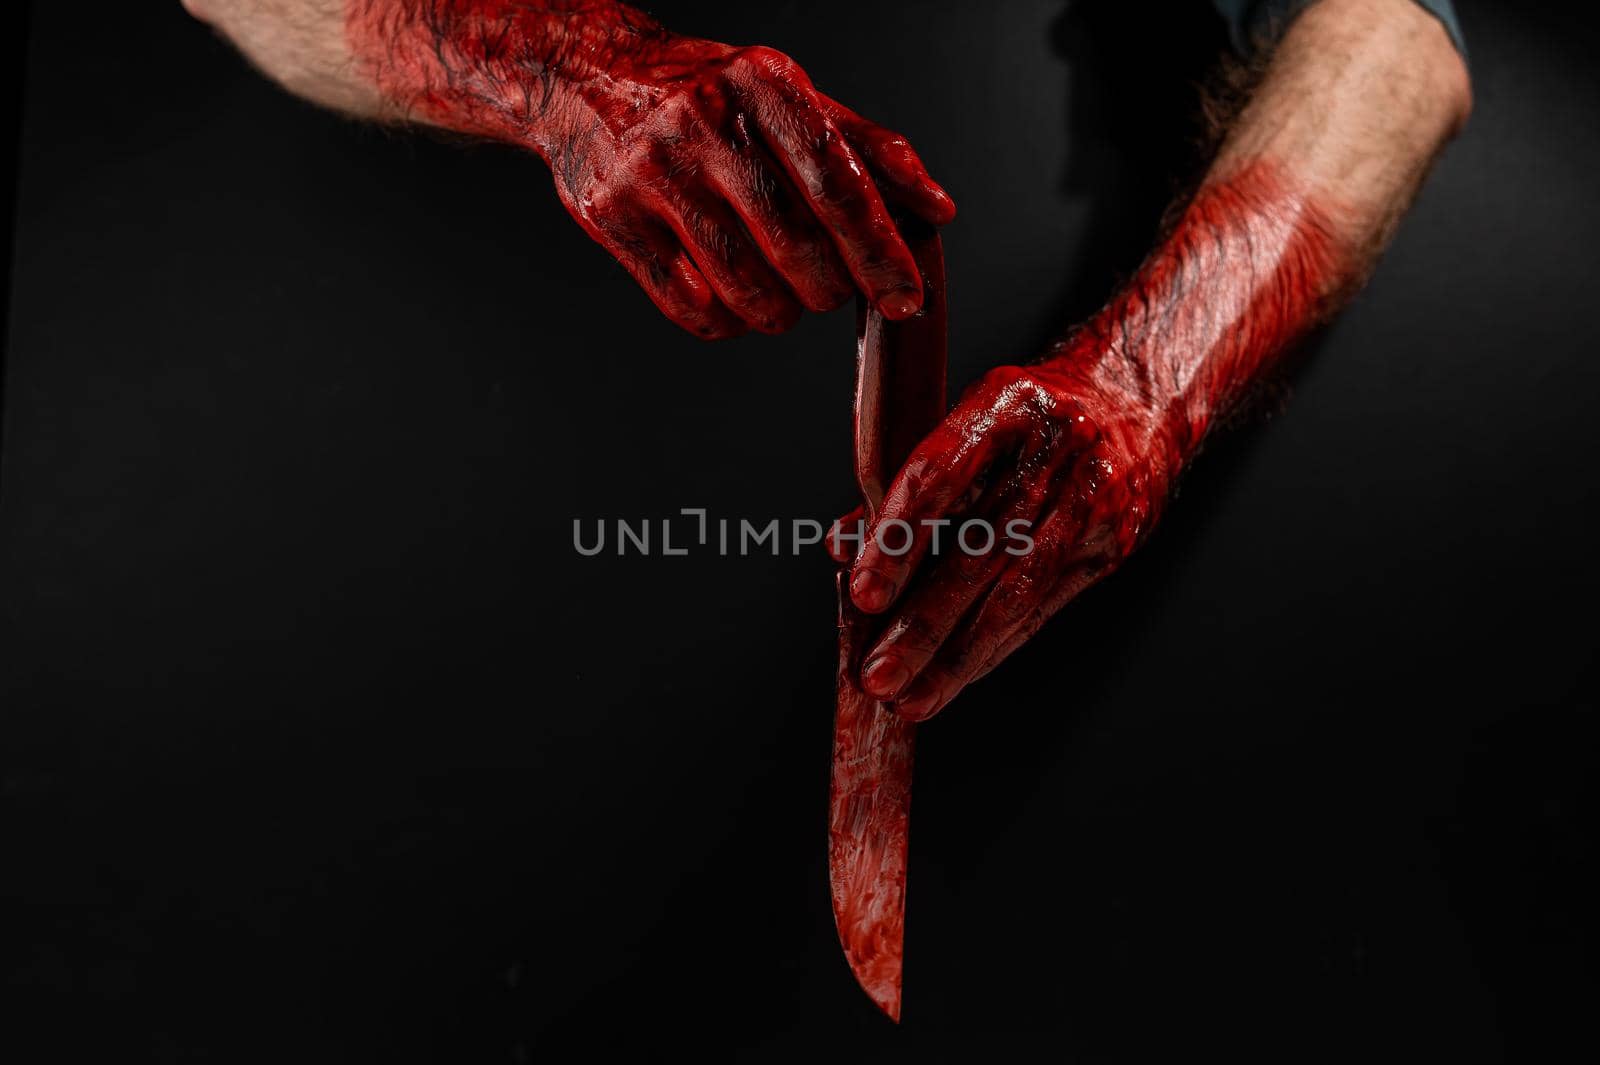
[827,222,946,1022]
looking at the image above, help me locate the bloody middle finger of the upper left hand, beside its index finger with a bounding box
[706,122,856,310]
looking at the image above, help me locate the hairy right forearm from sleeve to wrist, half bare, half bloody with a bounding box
[1040,0,1470,467]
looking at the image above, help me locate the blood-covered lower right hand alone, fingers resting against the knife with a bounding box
[851,356,1176,721]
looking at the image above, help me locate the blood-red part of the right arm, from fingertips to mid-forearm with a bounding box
[832,163,1349,721]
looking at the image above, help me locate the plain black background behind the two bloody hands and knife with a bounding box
[0,0,1600,1063]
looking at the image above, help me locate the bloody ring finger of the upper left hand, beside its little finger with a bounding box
[656,184,800,333]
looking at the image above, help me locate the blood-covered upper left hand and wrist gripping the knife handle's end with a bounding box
[347,0,955,337]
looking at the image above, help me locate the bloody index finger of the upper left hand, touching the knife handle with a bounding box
[736,48,922,320]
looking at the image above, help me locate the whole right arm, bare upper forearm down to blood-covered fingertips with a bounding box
[850,0,1470,720]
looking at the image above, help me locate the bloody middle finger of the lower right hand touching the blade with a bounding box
[861,478,1048,699]
